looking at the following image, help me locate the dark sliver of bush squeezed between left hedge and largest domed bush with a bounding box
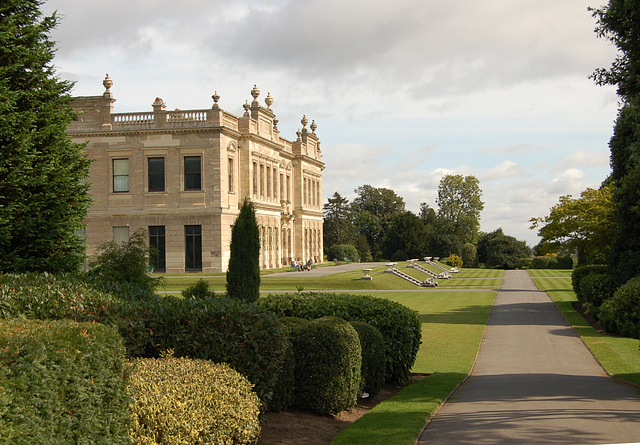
[267,317,311,411]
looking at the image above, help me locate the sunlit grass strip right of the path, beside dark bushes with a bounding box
[530,271,640,385]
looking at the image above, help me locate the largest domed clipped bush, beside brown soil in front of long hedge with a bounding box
[291,317,362,414]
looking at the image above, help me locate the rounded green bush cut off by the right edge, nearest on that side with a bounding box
[598,277,640,338]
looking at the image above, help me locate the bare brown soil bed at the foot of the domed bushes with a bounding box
[258,374,427,445]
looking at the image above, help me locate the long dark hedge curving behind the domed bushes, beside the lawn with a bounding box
[257,293,422,383]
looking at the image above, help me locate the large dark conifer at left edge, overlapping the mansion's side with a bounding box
[0,0,90,272]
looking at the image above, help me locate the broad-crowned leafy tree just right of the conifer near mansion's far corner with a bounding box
[351,185,405,259]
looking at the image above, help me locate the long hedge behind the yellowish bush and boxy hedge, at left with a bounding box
[0,274,286,404]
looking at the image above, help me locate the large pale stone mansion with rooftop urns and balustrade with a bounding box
[68,75,324,273]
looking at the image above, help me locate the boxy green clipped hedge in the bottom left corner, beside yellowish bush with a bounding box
[0,319,130,445]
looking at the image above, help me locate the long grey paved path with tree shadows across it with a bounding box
[418,271,640,445]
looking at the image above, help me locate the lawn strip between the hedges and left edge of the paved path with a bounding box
[332,291,496,445]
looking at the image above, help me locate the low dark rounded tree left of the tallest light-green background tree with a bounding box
[384,212,428,258]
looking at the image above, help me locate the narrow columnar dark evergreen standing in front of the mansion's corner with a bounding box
[227,198,260,303]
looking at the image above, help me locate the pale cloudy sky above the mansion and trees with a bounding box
[42,0,619,247]
